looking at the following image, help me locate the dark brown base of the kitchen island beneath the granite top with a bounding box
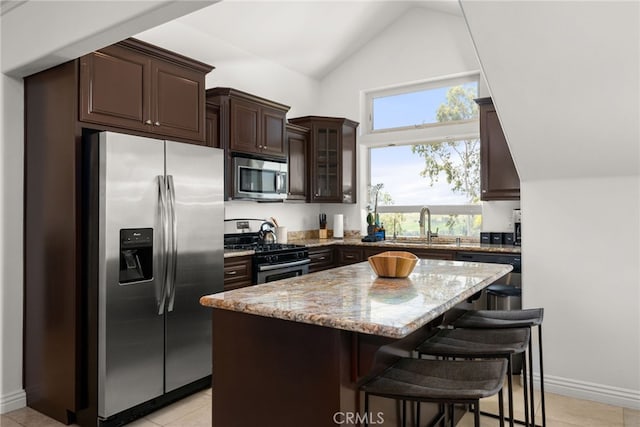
[212,309,438,427]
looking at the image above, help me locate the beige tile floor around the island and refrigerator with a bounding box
[0,385,640,427]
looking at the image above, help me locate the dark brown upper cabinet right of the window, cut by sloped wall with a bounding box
[476,98,520,200]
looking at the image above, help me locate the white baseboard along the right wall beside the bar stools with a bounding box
[533,372,640,410]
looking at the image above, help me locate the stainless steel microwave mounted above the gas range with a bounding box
[233,156,288,201]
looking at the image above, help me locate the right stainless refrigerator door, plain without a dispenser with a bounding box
[165,141,224,392]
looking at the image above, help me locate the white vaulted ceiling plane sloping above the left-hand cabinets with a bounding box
[135,0,461,79]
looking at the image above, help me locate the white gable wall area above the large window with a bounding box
[318,7,480,124]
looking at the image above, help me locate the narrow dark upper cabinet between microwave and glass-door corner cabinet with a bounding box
[287,123,309,200]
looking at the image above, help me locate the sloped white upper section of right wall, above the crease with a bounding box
[462,0,640,181]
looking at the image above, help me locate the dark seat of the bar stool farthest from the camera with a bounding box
[453,308,544,329]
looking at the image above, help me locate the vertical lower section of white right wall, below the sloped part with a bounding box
[522,176,640,409]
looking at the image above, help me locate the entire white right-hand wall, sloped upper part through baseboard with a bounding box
[461,0,640,408]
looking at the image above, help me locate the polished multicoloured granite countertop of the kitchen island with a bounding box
[200,259,512,338]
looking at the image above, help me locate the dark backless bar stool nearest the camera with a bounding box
[360,358,507,427]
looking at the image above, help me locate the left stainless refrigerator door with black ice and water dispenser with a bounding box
[97,132,164,418]
